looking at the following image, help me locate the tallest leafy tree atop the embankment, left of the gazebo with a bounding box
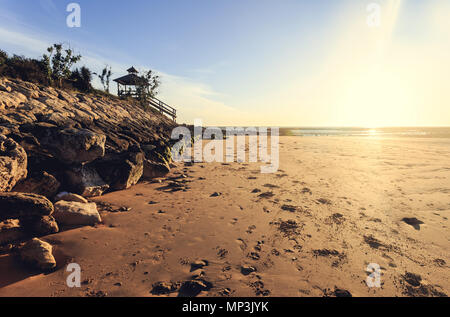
[43,43,81,87]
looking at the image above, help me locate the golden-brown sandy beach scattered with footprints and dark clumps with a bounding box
[0,136,450,297]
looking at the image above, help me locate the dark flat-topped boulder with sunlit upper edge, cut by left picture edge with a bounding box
[0,193,53,221]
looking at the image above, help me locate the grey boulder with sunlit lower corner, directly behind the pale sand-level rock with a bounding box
[66,165,109,197]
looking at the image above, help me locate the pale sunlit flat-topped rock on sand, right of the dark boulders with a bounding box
[54,200,102,226]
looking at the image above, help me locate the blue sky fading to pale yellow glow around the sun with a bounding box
[0,0,450,127]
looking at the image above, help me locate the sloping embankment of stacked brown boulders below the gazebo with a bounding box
[0,78,175,198]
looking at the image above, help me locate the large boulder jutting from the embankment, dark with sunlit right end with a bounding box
[38,128,106,164]
